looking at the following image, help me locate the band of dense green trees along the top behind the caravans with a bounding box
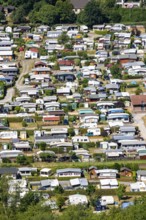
[0,0,146,27]
